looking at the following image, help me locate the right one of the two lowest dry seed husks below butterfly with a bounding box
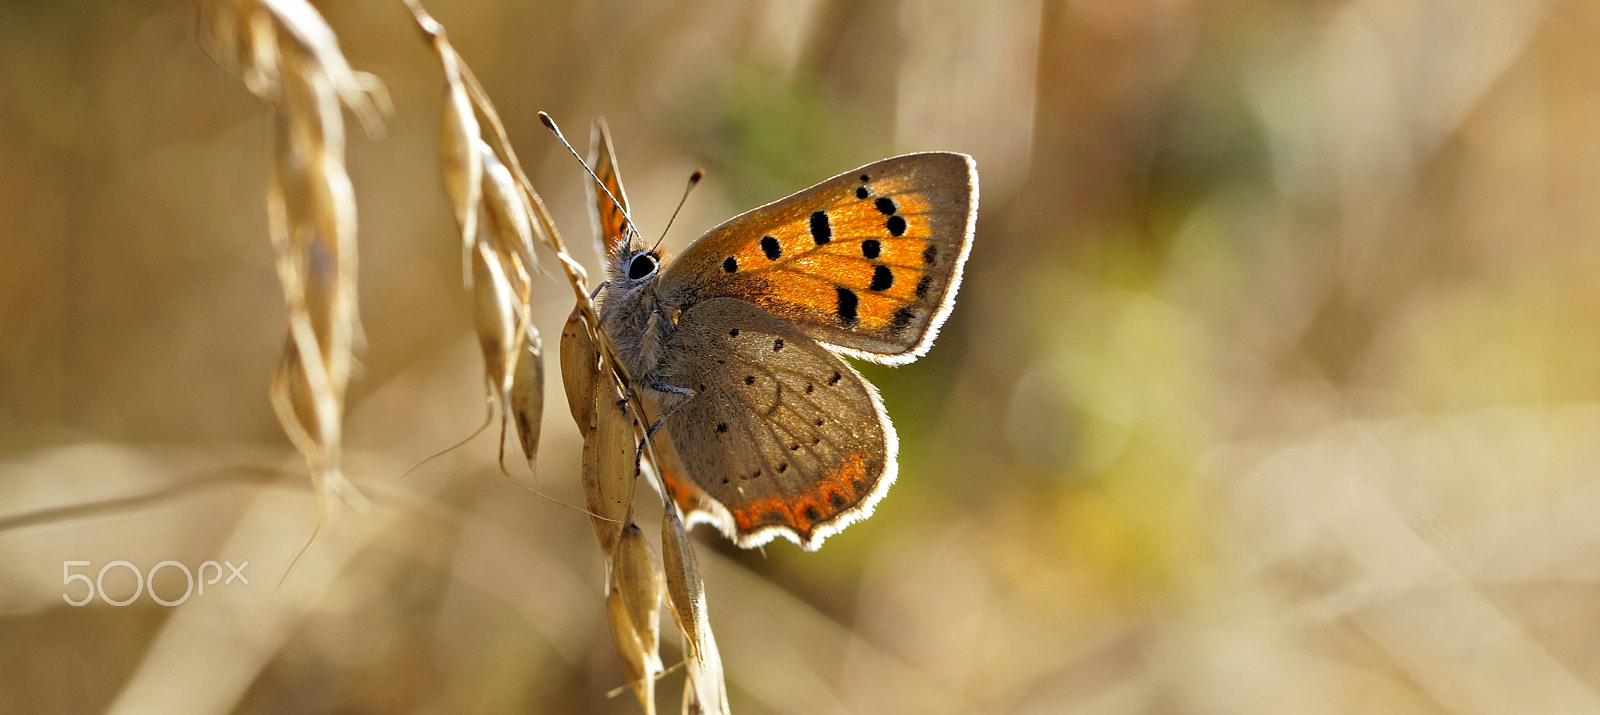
[661,499,728,713]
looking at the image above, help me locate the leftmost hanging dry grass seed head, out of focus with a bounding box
[202,0,387,553]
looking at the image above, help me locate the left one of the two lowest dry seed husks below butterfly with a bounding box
[606,523,666,712]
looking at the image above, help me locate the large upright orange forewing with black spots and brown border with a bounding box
[661,152,978,363]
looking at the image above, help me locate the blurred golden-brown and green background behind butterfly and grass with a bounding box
[0,0,1600,713]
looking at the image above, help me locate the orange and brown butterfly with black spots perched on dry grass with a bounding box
[590,123,978,550]
